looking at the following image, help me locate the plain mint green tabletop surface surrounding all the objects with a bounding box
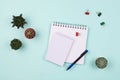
[0,0,120,80]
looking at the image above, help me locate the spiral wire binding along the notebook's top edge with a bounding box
[52,22,87,30]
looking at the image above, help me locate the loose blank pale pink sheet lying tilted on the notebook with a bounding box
[46,33,74,66]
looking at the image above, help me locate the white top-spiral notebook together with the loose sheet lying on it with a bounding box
[46,22,88,66]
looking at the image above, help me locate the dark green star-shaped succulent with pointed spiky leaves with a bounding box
[11,14,26,29]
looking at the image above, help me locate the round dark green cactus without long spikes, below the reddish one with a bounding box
[10,39,22,50]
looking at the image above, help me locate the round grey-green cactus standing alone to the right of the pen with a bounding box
[95,57,108,69]
